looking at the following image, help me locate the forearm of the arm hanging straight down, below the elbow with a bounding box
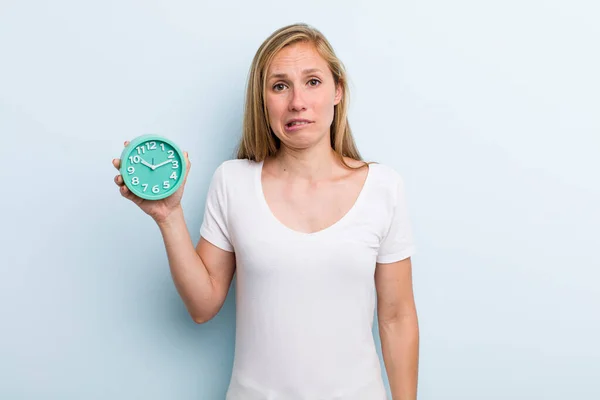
[379,314,419,400]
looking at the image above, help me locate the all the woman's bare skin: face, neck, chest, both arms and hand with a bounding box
[113,39,419,400]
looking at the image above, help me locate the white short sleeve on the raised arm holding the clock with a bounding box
[200,163,233,251]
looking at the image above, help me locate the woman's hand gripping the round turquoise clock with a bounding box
[112,141,191,223]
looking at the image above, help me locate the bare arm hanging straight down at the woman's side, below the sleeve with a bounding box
[375,257,419,400]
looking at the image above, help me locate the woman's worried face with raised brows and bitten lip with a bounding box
[265,42,342,149]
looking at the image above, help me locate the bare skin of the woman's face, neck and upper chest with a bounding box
[262,39,368,232]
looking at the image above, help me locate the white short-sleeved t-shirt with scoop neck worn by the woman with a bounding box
[200,160,415,400]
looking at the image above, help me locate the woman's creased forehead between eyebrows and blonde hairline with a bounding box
[268,42,328,75]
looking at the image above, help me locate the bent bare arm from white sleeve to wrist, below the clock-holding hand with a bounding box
[158,207,235,323]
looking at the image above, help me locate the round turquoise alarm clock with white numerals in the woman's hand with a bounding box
[120,134,186,200]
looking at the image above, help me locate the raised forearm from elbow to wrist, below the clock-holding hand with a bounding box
[157,207,218,322]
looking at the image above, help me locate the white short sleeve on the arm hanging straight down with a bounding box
[377,174,416,263]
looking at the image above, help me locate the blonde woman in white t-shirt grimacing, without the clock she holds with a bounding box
[113,24,418,400]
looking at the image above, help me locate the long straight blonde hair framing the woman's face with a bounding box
[237,24,362,167]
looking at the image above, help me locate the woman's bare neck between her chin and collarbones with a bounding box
[273,143,337,181]
